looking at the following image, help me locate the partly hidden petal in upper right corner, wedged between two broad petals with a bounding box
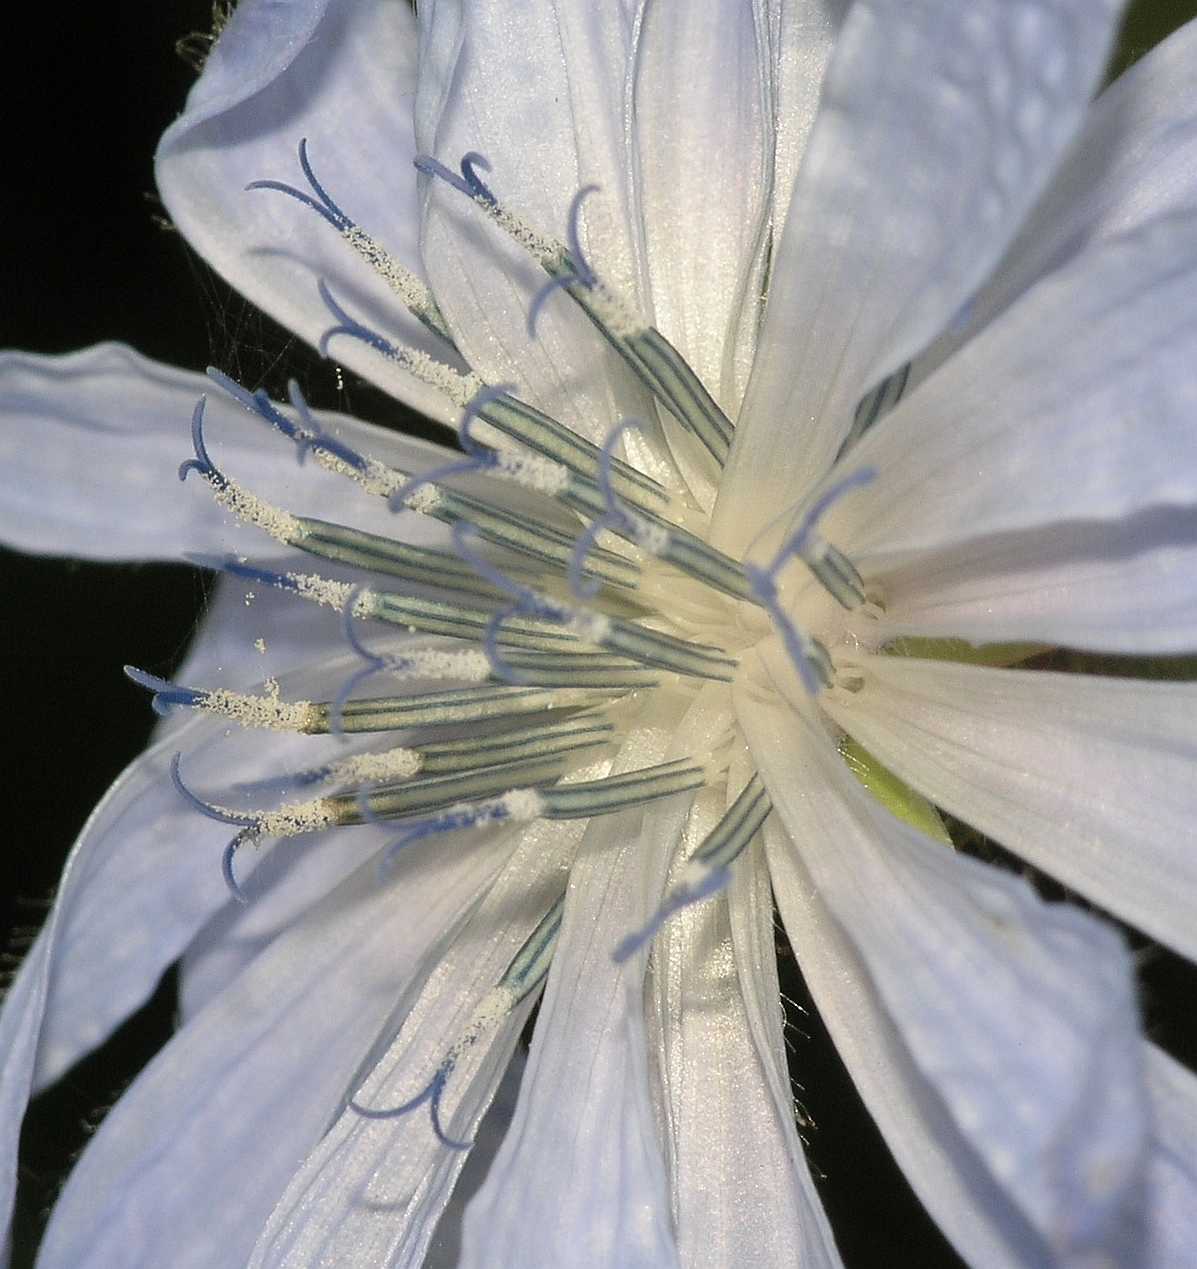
[924,22,1197,391]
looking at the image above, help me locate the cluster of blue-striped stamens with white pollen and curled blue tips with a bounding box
[128,142,872,1147]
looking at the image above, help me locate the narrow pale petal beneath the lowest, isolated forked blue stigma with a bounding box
[250,821,584,1269]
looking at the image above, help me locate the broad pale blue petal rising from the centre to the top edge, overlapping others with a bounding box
[716,0,1118,552]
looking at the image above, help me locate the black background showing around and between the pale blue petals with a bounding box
[0,0,1197,1269]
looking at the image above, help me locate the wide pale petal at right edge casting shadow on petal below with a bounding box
[826,214,1197,565]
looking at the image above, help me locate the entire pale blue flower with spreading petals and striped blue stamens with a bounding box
[7,0,1197,1269]
